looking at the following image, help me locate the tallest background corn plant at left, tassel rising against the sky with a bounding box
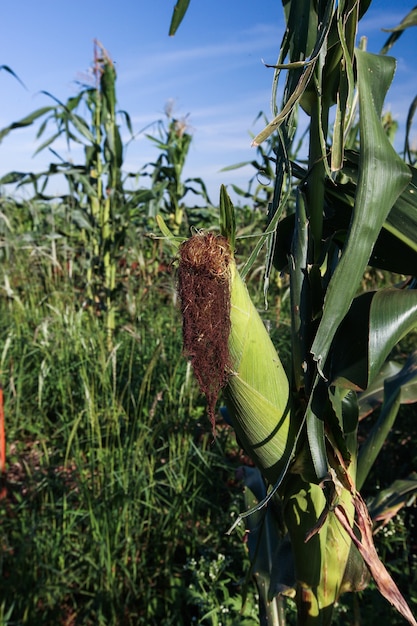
[0,41,153,347]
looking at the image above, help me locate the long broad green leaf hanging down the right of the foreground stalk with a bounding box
[312,50,411,371]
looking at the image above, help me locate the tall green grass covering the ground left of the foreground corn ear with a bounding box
[0,236,256,625]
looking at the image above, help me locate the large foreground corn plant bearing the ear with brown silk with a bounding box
[168,0,417,626]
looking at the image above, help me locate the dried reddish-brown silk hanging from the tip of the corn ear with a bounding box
[178,233,232,428]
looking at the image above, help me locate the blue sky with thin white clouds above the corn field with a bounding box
[0,0,417,202]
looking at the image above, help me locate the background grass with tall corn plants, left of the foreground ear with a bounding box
[0,42,264,626]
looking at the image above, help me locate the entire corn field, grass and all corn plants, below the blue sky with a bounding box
[0,0,417,626]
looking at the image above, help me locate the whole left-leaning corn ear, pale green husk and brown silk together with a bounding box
[178,233,296,484]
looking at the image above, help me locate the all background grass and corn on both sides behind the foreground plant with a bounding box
[0,3,417,626]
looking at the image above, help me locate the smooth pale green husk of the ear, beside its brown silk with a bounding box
[224,260,296,484]
